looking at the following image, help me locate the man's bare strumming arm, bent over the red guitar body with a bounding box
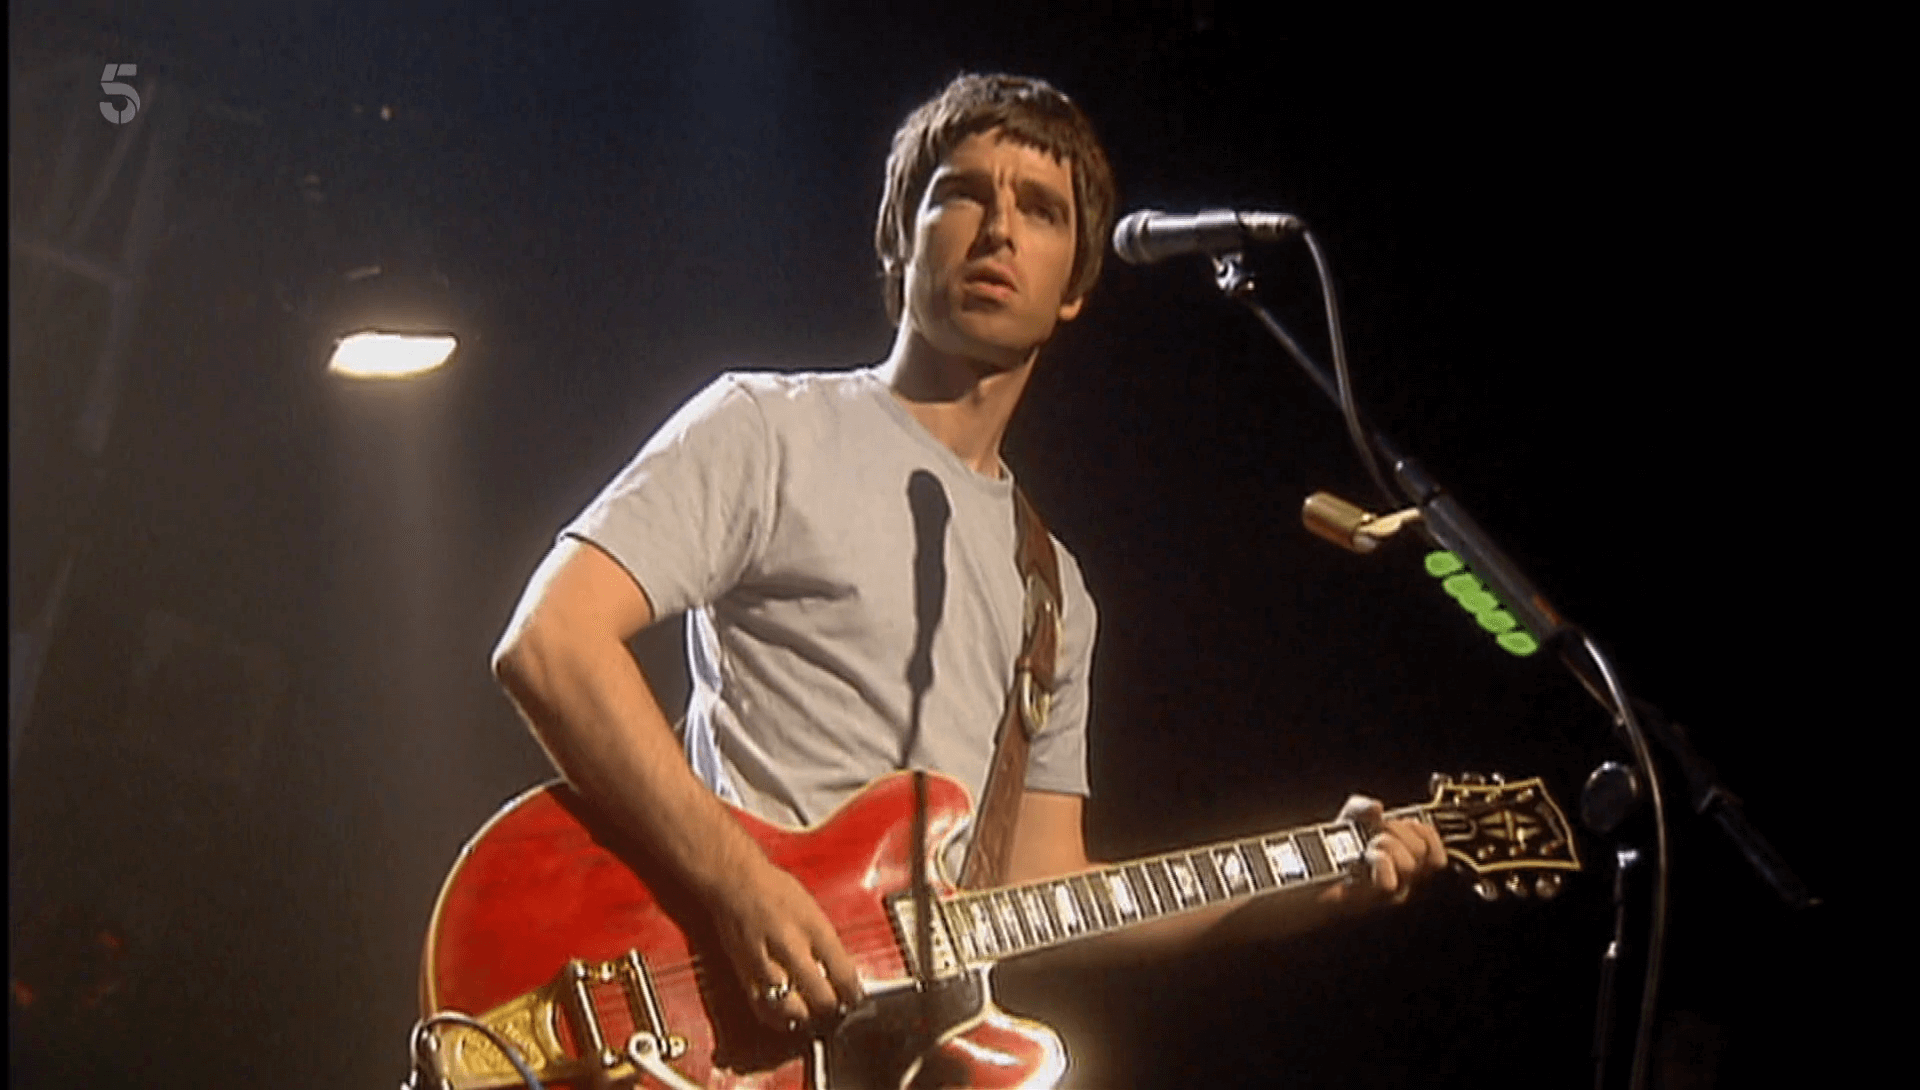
[493,539,860,1025]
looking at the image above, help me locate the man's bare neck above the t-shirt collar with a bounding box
[879,326,1039,478]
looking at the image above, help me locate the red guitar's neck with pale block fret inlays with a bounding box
[935,806,1430,969]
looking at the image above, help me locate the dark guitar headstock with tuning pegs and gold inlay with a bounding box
[1425,773,1580,900]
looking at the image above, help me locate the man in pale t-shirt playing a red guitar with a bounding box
[493,75,1446,1066]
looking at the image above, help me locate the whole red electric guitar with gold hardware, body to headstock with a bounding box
[420,773,1580,1090]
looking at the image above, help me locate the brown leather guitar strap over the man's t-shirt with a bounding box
[960,486,1062,889]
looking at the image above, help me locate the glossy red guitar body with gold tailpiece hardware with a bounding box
[420,773,1066,1090]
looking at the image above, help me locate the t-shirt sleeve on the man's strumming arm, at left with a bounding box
[561,374,774,620]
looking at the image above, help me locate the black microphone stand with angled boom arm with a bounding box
[1212,247,1818,1090]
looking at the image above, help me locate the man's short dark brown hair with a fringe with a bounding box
[874,73,1117,324]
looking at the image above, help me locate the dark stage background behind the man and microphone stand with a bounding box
[10,0,1872,1088]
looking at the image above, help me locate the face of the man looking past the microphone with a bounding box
[906,129,1083,368]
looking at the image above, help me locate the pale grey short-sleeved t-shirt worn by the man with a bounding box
[563,368,1096,825]
